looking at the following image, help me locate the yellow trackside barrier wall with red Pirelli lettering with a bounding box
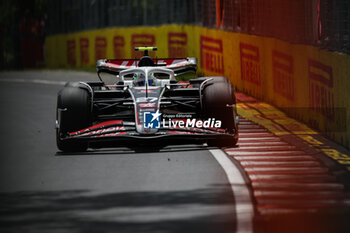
[46,25,350,147]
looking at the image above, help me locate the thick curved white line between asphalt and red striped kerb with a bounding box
[209,149,254,233]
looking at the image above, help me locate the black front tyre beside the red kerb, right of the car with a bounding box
[202,77,238,147]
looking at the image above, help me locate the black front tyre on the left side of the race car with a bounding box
[56,86,92,152]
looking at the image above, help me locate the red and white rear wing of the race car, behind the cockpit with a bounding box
[96,57,197,75]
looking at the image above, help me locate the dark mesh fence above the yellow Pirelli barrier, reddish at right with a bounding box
[47,0,350,53]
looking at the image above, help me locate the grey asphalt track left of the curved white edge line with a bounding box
[0,71,249,233]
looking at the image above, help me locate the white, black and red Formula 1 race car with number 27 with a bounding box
[56,47,238,152]
